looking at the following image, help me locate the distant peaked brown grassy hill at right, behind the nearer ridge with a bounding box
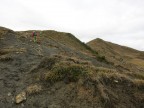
[87,38,144,68]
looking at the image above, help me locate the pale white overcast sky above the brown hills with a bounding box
[0,0,144,51]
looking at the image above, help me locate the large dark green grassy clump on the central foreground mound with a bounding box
[41,65,88,82]
